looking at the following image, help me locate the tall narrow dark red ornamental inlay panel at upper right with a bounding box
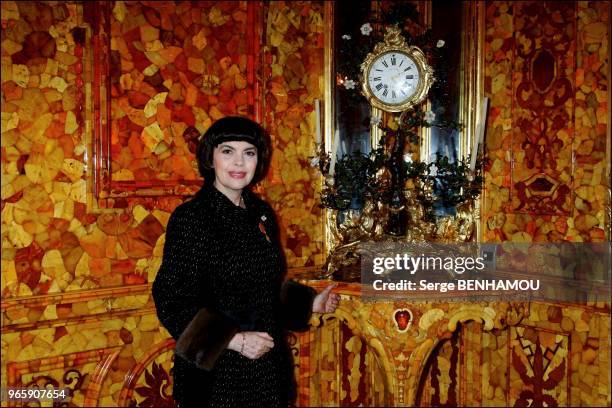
[509,2,577,216]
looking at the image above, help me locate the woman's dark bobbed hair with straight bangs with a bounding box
[196,116,270,185]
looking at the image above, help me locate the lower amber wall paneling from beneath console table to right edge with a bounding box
[419,303,610,406]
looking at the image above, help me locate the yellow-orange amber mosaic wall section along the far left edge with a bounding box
[2,2,95,298]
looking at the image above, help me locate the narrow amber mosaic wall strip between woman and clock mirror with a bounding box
[263,1,325,267]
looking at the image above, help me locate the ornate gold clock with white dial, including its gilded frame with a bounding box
[361,26,434,112]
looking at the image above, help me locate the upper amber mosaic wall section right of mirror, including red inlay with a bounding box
[483,1,610,242]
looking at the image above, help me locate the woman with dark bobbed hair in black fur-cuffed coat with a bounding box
[153,117,339,407]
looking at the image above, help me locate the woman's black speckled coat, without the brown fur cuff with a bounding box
[153,186,315,407]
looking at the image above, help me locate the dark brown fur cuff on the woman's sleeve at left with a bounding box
[176,308,238,370]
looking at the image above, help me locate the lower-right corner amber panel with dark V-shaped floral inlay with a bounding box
[481,303,611,406]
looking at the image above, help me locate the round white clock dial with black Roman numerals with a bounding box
[367,51,420,105]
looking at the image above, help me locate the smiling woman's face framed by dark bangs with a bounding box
[213,141,257,192]
